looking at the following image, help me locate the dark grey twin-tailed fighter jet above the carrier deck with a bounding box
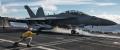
[10,5,116,32]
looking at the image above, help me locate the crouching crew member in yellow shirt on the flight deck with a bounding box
[14,28,36,47]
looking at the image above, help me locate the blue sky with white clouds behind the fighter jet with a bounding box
[0,0,120,24]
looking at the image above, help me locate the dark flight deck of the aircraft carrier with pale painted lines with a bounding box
[0,4,120,50]
